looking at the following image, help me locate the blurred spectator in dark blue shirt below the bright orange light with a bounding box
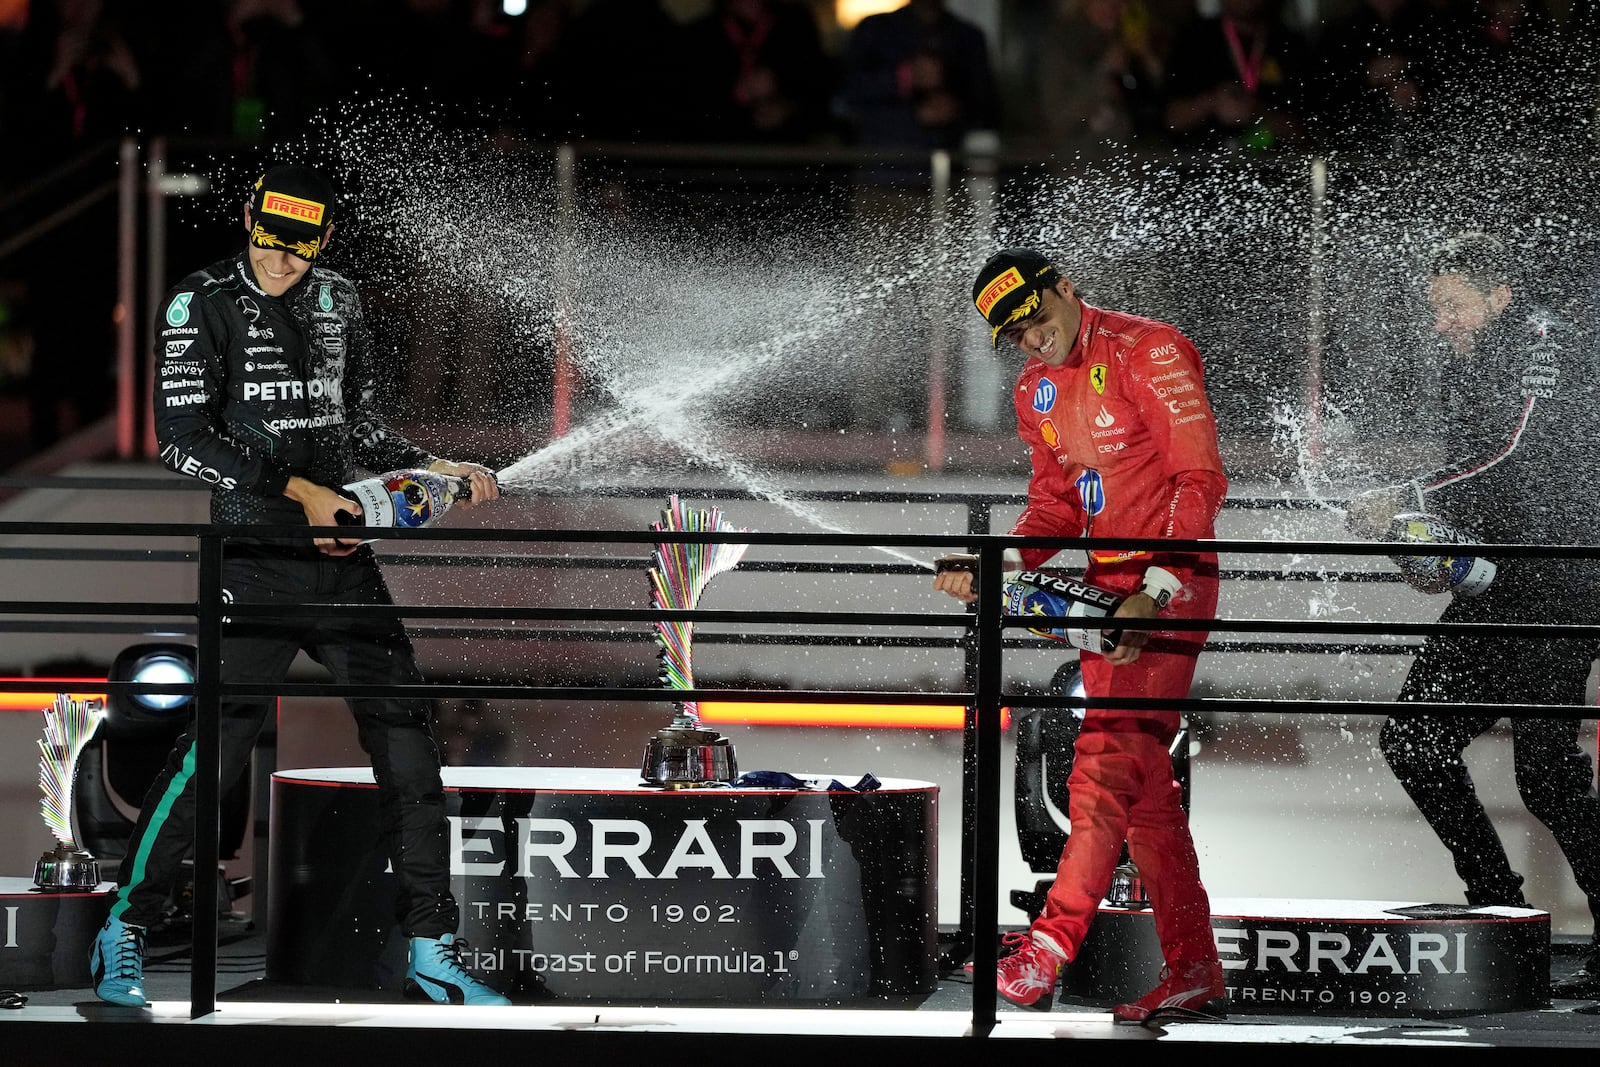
[840,0,998,150]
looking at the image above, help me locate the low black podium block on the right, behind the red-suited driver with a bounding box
[1062,897,1550,1017]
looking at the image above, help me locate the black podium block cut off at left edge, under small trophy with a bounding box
[0,878,115,989]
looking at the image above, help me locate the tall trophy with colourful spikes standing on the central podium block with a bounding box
[642,494,750,789]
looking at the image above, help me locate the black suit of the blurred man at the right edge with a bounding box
[1381,304,1600,917]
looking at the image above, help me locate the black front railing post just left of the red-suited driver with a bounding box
[973,539,1005,1037]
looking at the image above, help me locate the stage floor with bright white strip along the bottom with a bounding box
[9,926,1600,1067]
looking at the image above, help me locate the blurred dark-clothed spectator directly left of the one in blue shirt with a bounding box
[678,0,834,142]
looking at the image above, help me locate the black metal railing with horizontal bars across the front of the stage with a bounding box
[0,480,1600,1035]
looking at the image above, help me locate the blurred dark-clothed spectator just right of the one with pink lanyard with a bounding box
[1317,0,1438,154]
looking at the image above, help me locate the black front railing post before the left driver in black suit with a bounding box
[189,533,222,1019]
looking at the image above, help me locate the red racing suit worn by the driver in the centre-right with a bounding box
[1011,304,1227,968]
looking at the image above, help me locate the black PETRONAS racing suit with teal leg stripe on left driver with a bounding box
[112,254,458,937]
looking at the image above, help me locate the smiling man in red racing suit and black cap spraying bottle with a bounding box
[934,250,1227,1022]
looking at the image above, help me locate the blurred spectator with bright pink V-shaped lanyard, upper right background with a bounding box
[1166,0,1310,150]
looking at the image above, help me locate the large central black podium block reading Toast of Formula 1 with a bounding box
[267,766,938,1003]
